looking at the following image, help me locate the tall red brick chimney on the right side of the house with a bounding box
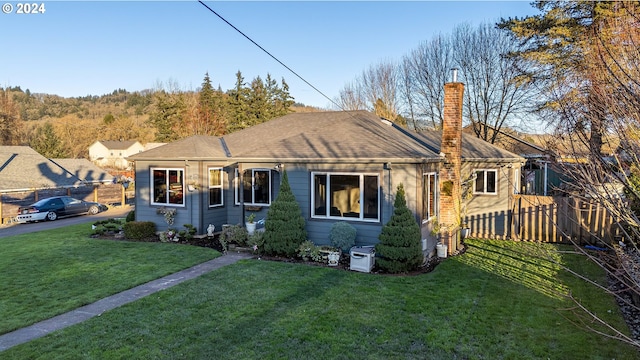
[439,69,464,253]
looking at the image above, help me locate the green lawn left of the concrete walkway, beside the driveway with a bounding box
[0,224,220,334]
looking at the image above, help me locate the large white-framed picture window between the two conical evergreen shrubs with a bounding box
[311,172,380,221]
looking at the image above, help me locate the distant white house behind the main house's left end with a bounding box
[89,140,145,169]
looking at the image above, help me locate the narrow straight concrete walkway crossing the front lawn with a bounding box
[0,253,252,352]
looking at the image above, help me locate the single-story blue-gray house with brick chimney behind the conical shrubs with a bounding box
[129,83,524,252]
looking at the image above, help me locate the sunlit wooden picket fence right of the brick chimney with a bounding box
[508,195,619,245]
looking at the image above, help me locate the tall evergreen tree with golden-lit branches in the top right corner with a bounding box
[498,0,640,158]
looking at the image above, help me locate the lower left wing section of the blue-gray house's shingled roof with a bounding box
[127,135,228,160]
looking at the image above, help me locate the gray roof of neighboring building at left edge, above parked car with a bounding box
[0,146,80,192]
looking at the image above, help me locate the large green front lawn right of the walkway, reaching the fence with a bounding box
[0,240,638,359]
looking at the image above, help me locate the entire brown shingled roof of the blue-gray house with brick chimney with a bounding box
[128,111,522,163]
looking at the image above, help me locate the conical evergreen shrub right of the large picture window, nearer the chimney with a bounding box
[376,184,422,273]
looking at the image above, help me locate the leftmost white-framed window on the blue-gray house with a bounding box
[151,168,184,206]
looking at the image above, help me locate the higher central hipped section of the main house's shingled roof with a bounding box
[224,111,437,162]
